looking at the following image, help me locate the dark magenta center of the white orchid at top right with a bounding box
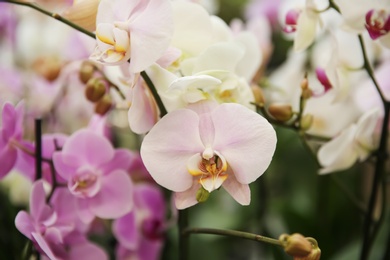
[365,10,390,40]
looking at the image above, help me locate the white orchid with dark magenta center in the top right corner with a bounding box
[335,0,390,48]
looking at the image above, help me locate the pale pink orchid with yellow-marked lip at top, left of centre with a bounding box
[91,0,173,73]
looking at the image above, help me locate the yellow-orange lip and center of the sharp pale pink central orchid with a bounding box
[187,148,228,192]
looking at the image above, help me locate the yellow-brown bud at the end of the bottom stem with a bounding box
[279,233,313,259]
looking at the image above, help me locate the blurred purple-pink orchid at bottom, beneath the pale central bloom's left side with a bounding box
[113,184,165,260]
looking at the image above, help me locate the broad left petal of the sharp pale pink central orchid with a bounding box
[141,109,204,192]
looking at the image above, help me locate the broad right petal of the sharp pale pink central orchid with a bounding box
[211,103,276,184]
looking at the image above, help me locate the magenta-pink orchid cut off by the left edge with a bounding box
[0,102,24,179]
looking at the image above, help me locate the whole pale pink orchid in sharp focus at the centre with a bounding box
[141,101,276,209]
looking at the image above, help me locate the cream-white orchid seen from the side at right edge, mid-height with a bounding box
[317,108,379,174]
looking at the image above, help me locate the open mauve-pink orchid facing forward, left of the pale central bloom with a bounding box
[53,129,133,223]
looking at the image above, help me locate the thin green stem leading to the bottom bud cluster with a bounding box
[184,228,283,247]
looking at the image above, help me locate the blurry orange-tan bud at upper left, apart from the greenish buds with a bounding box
[32,56,62,81]
